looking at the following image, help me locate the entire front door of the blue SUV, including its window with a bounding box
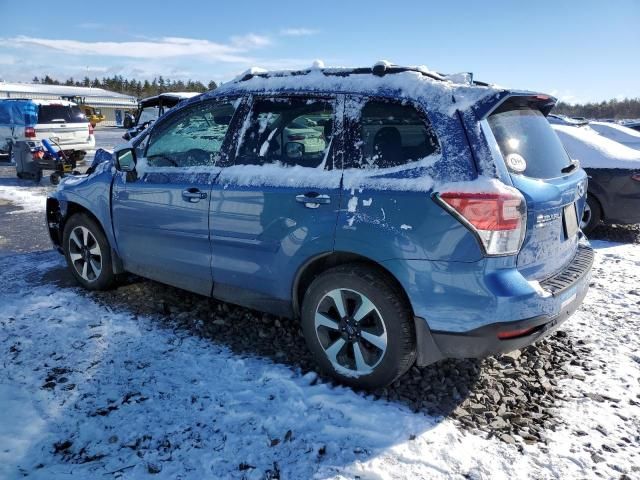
[113,100,241,295]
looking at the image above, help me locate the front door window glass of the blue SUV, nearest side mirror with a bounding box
[146,103,235,167]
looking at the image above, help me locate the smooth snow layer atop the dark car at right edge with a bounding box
[551,125,640,169]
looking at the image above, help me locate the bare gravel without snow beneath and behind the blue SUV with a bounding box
[44,253,584,443]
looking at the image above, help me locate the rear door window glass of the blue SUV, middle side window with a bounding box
[235,98,334,168]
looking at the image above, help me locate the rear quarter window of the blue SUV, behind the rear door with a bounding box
[351,100,440,168]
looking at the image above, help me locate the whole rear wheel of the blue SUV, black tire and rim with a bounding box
[302,264,416,389]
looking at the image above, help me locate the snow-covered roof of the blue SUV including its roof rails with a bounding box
[208,62,504,114]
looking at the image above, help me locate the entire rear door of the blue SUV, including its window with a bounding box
[210,97,342,303]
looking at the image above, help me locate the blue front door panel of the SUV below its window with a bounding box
[113,168,220,295]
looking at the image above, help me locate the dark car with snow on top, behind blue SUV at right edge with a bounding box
[552,122,640,233]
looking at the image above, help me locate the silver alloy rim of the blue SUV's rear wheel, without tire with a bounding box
[315,288,387,377]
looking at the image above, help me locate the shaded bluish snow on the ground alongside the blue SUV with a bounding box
[0,251,476,479]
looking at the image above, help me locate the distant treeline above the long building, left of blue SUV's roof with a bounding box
[32,75,218,98]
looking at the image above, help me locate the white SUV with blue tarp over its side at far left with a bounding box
[0,99,96,168]
